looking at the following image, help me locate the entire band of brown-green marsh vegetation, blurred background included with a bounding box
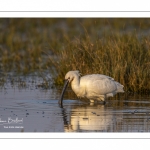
[0,18,150,93]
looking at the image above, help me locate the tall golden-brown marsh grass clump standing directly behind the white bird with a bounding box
[50,33,150,92]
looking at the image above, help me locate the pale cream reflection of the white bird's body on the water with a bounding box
[64,105,113,132]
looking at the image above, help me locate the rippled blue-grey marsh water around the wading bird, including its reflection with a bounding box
[0,74,150,132]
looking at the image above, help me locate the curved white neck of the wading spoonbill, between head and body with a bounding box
[71,76,80,95]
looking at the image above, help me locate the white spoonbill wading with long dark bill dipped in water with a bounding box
[59,70,124,105]
